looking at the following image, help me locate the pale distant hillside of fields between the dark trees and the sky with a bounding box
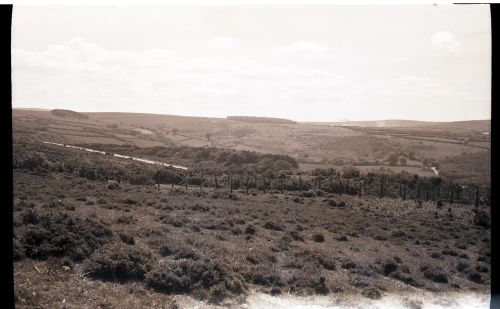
[13,110,490,182]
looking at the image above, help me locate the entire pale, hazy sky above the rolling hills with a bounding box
[12,5,491,122]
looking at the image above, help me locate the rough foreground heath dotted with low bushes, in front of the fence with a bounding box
[14,170,491,308]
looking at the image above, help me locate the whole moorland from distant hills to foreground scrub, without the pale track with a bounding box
[13,110,491,308]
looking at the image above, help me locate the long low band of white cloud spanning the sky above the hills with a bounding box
[12,31,487,121]
